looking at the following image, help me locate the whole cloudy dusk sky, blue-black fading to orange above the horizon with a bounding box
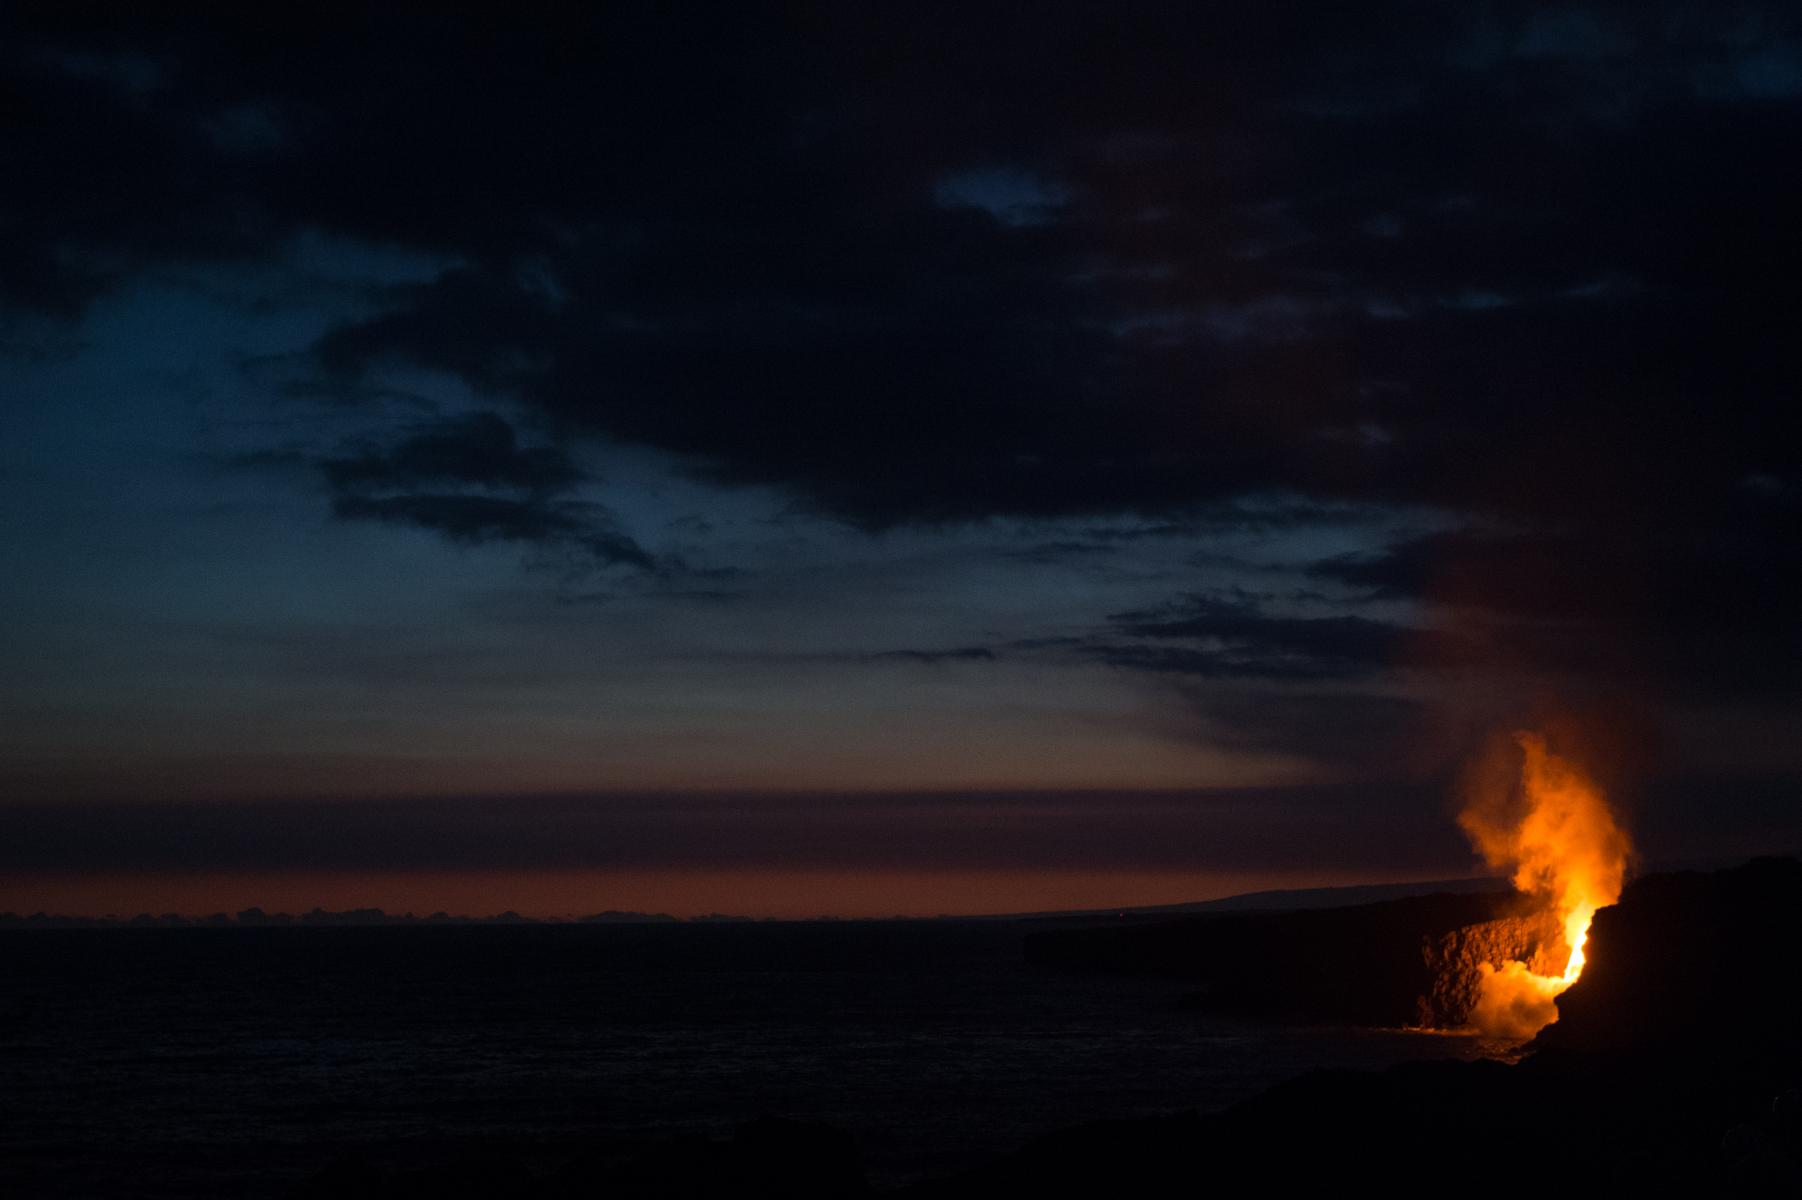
[0,0,1802,912]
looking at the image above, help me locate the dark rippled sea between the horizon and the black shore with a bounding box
[0,923,1479,1196]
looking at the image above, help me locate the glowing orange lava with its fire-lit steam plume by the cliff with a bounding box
[1458,733,1631,1038]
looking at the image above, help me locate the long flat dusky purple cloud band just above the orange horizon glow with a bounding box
[0,786,1469,872]
